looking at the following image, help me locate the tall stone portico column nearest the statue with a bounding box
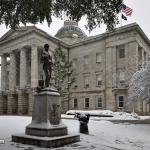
[31,45,38,88]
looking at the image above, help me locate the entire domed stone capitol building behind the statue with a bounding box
[0,21,150,115]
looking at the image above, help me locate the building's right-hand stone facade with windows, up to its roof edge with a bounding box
[69,24,150,114]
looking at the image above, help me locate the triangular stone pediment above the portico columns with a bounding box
[0,26,35,41]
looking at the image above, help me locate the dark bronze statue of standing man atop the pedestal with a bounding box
[41,44,52,87]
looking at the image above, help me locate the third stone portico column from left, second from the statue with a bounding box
[20,48,27,89]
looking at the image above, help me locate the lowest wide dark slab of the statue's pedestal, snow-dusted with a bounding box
[12,134,80,148]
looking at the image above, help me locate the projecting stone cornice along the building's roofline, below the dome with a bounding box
[0,23,150,48]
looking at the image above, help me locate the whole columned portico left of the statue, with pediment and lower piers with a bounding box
[0,26,62,115]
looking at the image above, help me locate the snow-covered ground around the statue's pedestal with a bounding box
[0,116,150,150]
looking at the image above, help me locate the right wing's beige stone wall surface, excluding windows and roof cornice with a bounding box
[70,31,150,113]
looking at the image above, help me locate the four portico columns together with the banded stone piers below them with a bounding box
[0,45,38,115]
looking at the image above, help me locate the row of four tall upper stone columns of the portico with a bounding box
[1,45,38,91]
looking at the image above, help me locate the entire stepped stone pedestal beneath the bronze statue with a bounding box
[12,89,80,147]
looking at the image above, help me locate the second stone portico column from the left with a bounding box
[9,52,16,91]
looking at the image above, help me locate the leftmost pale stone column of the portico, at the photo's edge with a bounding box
[1,54,7,91]
